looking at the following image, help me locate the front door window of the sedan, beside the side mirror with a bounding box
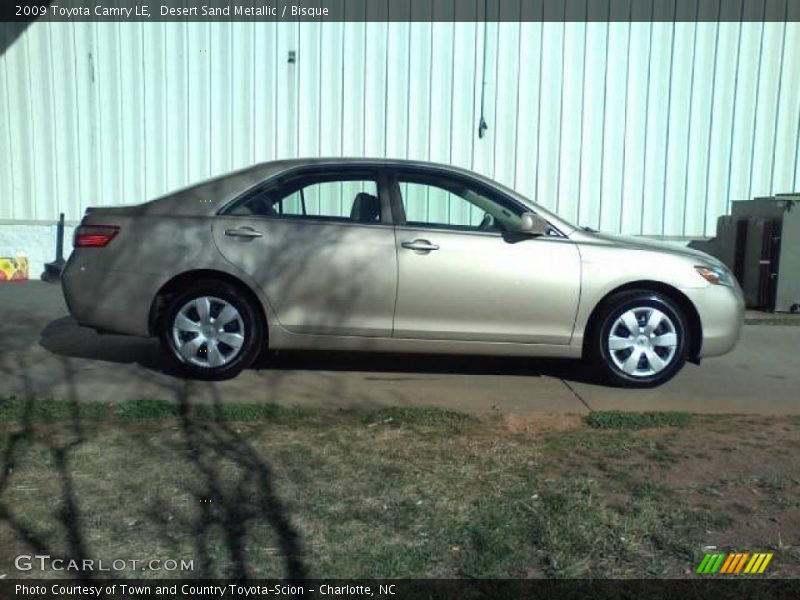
[399,178,520,231]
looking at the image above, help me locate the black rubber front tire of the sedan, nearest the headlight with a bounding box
[587,290,690,388]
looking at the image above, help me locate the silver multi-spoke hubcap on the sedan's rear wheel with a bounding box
[172,296,245,368]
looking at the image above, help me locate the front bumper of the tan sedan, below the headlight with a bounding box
[683,284,744,358]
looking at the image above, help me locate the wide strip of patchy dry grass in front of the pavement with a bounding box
[0,401,800,578]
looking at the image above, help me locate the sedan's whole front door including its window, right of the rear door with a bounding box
[393,171,580,344]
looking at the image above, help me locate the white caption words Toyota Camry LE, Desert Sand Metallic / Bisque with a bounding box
[47,4,330,19]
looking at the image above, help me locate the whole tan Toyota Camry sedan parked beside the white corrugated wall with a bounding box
[63,159,744,387]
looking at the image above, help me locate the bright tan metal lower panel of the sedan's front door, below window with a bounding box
[394,226,581,344]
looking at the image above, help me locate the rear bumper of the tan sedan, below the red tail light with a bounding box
[61,248,165,336]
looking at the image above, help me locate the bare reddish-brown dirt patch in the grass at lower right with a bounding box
[536,416,800,577]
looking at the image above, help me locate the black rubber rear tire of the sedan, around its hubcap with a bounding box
[158,280,265,381]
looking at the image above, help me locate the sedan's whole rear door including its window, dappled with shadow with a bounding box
[213,169,397,336]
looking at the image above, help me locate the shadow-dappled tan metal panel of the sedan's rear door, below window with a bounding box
[213,216,397,337]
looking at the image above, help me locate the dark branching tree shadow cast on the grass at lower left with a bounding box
[0,356,308,581]
